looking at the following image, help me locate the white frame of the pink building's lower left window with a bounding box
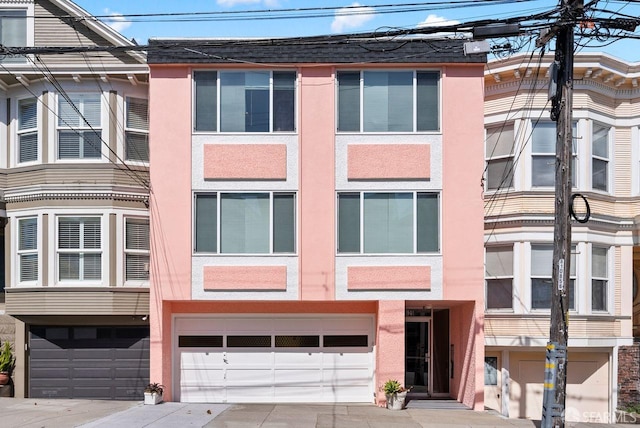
[192,190,299,256]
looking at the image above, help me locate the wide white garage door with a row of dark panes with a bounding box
[174,315,374,403]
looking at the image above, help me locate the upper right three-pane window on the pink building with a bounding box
[338,70,440,132]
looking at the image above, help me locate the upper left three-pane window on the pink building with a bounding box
[193,71,296,132]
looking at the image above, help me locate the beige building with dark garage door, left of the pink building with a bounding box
[0,0,149,399]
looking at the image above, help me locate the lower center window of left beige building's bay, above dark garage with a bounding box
[57,217,102,281]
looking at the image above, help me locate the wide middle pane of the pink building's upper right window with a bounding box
[363,71,413,132]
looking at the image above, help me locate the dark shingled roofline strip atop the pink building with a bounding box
[147,36,487,65]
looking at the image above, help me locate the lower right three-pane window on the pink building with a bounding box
[338,192,440,254]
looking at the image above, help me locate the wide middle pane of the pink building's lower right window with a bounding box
[364,193,413,253]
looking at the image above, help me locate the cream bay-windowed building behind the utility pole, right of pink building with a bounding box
[484,53,640,422]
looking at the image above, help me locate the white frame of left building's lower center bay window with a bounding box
[53,214,106,285]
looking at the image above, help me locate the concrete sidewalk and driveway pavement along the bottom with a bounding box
[0,398,628,428]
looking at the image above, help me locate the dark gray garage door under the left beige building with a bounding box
[29,326,149,400]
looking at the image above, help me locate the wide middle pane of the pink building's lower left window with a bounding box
[220,193,270,254]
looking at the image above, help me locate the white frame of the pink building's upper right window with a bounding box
[335,68,443,134]
